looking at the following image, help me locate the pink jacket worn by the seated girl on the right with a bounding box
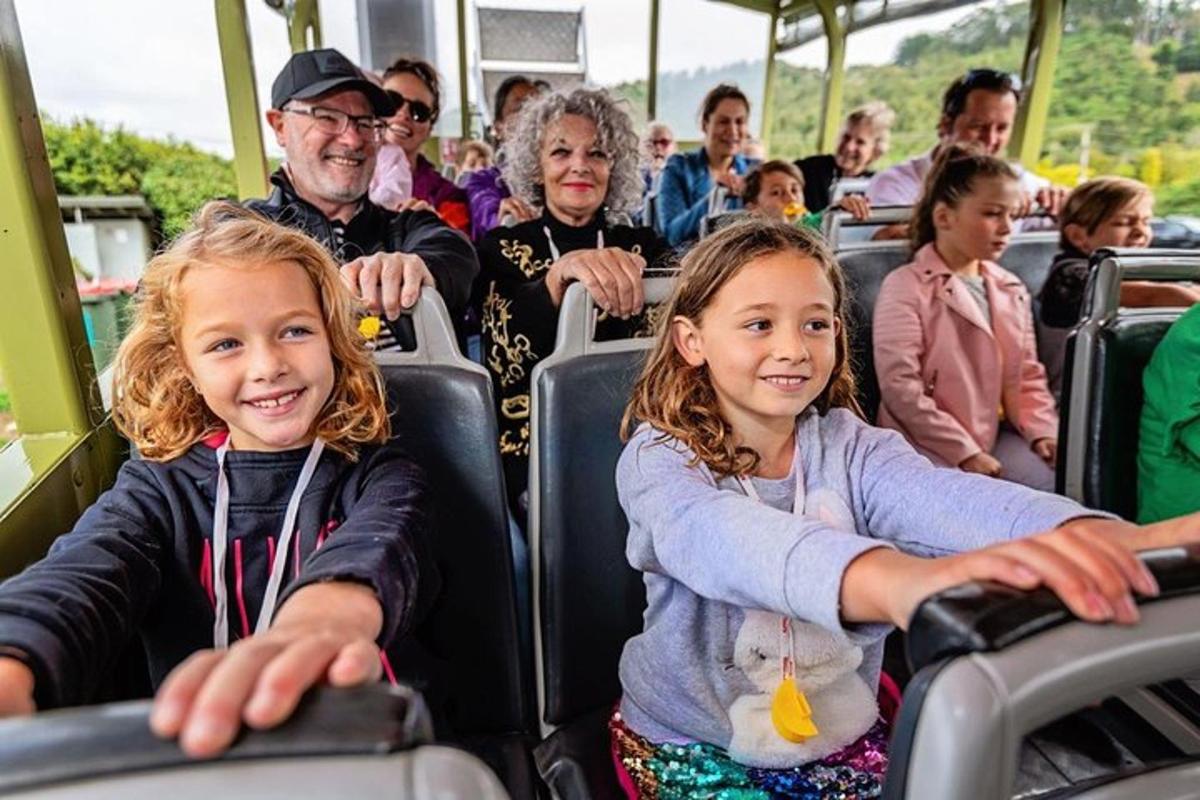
[872,245,1058,467]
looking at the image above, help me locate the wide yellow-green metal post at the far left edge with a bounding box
[0,0,95,437]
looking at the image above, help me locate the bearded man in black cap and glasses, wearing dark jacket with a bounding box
[247,49,479,345]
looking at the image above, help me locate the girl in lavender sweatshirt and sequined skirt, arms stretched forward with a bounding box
[610,219,1200,798]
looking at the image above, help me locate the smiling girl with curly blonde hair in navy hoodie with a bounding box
[0,203,428,756]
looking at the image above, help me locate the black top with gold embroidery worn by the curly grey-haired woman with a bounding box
[478,211,671,509]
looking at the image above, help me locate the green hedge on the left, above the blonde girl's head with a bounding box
[42,118,238,239]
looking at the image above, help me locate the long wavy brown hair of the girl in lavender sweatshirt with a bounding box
[620,217,863,475]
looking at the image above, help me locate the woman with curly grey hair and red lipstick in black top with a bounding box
[476,88,670,516]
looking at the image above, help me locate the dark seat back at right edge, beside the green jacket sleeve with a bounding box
[1057,249,1200,519]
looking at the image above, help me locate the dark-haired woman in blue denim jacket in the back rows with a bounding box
[655,83,757,247]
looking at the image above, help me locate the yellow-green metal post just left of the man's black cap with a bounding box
[216,0,266,199]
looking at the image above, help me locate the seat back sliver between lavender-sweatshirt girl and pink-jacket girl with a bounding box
[838,241,911,421]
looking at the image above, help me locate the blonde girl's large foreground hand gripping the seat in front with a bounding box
[150,583,383,758]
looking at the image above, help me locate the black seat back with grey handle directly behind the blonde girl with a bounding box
[377,289,534,738]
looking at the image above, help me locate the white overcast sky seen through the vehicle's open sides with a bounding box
[16,0,995,155]
